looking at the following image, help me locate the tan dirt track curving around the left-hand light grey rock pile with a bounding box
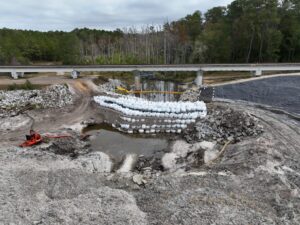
[1,78,103,145]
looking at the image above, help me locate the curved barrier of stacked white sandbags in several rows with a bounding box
[94,96,207,133]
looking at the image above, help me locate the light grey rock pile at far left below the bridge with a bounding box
[0,85,73,118]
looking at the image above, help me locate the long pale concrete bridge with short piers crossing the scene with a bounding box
[0,63,300,85]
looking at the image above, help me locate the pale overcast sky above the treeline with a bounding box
[0,0,232,31]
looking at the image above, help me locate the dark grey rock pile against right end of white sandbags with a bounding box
[185,106,263,144]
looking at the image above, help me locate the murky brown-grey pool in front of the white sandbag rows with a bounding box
[84,124,169,161]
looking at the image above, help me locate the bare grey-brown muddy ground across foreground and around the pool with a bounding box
[0,78,300,225]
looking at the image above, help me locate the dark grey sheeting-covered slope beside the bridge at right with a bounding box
[215,76,300,114]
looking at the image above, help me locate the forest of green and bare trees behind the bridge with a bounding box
[0,0,300,65]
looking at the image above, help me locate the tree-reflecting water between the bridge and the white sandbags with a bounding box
[136,80,184,102]
